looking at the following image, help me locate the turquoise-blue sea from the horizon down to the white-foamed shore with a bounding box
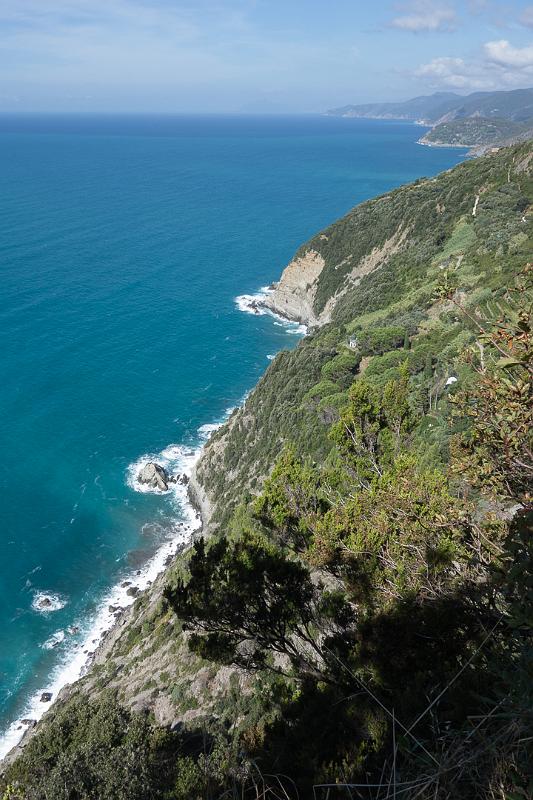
[0,115,464,755]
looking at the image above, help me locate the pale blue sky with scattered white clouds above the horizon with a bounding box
[0,0,533,113]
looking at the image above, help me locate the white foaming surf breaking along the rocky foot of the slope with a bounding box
[0,287,307,773]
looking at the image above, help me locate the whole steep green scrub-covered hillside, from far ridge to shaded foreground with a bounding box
[5,143,533,800]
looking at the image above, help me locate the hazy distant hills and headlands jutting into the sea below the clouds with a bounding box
[326,89,533,148]
